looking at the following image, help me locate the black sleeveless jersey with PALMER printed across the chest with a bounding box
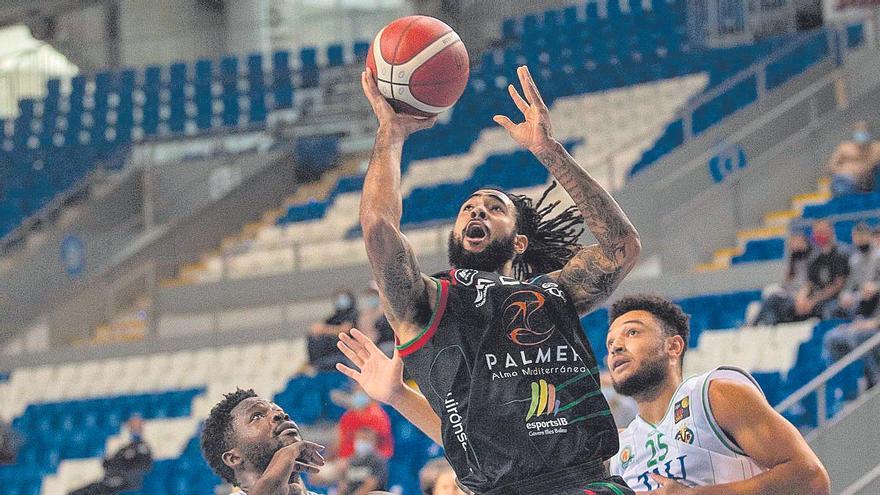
[398,270,618,494]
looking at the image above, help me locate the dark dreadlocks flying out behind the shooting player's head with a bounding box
[491,181,584,280]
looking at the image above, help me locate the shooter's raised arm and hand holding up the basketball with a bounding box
[360,72,437,334]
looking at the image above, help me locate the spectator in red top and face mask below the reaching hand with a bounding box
[338,385,394,459]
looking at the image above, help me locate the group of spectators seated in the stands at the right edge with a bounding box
[747,121,880,388]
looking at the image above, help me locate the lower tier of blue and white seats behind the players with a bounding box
[0,282,861,495]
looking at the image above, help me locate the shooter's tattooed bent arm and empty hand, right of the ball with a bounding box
[495,66,641,314]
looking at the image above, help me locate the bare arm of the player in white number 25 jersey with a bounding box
[651,379,831,495]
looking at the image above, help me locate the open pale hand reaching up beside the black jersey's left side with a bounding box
[336,328,404,404]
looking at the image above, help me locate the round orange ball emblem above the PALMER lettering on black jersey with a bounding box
[501,290,556,346]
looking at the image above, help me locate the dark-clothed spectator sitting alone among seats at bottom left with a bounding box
[70,415,153,495]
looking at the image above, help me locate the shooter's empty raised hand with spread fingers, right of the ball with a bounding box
[492,65,553,153]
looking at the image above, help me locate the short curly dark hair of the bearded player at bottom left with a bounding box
[199,388,257,483]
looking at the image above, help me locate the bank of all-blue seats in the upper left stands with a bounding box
[0,42,366,238]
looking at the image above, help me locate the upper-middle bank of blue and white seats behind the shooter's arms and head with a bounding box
[167,1,863,284]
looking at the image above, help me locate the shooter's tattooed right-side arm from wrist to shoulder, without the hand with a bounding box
[535,143,641,312]
